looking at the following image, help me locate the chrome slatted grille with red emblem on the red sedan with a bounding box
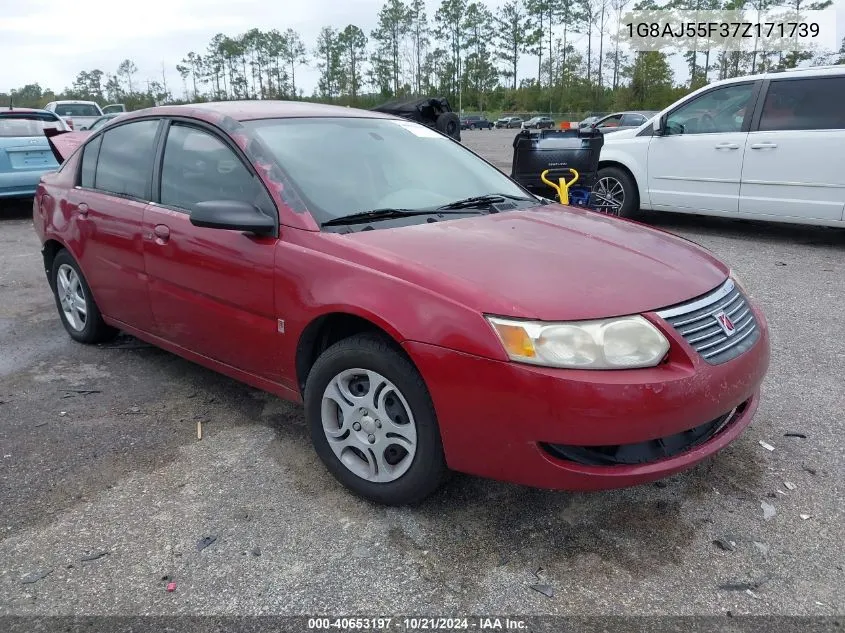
[657,279,760,365]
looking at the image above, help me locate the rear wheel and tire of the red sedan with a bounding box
[50,249,119,344]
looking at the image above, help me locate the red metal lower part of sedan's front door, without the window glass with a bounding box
[144,205,279,380]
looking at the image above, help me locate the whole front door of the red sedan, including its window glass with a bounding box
[144,123,281,381]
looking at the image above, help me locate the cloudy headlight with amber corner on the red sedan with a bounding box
[487,316,669,369]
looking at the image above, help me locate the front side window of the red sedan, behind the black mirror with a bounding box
[161,124,272,212]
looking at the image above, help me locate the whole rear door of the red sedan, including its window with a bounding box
[67,119,161,331]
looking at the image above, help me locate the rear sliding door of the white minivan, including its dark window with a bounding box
[739,75,845,222]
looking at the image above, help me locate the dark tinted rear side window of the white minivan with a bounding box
[760,77,845,132]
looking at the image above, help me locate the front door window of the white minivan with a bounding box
[666,83,754,135]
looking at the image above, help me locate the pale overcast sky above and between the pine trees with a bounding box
[0,0,845,96]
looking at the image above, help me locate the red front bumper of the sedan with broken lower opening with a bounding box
[405,300,770,490]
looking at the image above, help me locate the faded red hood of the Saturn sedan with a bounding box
[344,204,729,321]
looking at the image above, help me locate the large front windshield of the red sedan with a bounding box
[245,118,526,223]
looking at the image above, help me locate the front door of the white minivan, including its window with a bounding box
[648,82,757,214]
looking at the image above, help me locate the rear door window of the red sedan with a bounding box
[94,120,159,200]
